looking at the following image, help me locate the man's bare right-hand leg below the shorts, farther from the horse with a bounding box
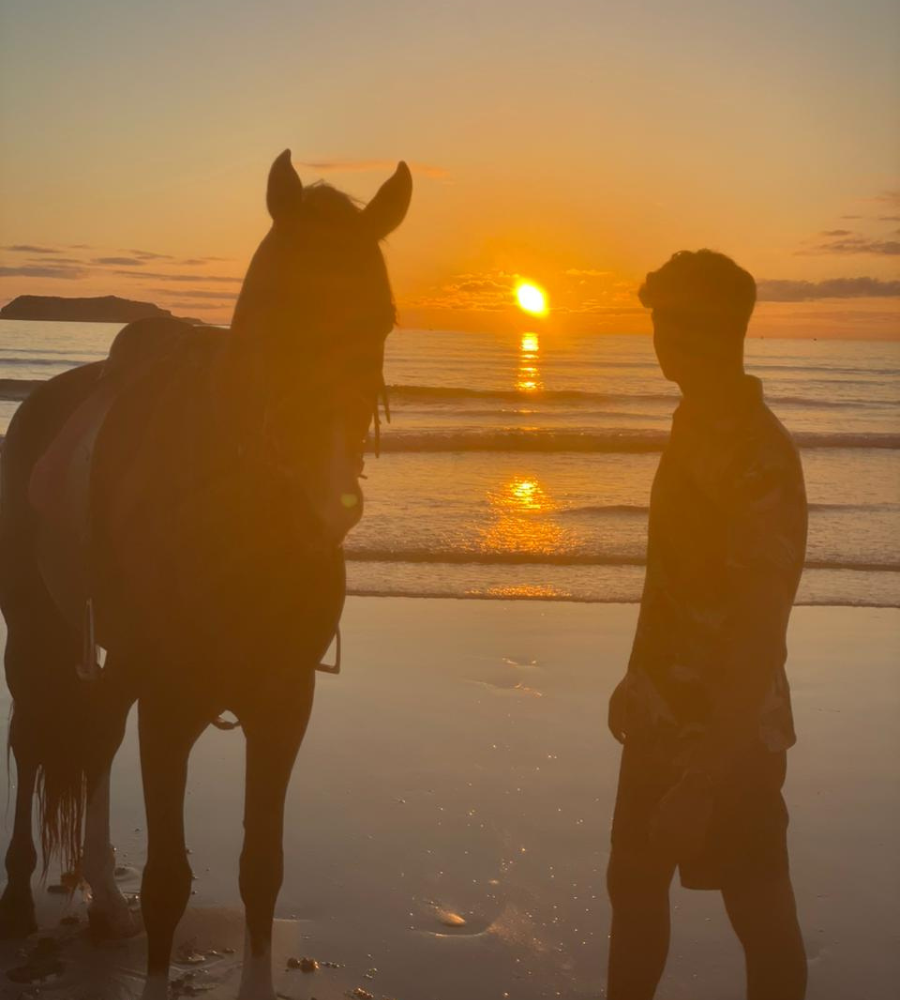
[722,872,806,1000]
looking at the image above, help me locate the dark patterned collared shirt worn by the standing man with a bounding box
[626,375,807,760]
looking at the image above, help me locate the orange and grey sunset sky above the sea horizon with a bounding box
[0,0,900,337]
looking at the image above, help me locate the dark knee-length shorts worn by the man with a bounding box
[612,741,789,889]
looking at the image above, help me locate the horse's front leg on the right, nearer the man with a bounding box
[238,670,315,1000]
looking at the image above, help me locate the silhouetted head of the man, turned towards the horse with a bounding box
[638,250,756,388]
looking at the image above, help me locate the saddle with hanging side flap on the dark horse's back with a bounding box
[28,318,194,656]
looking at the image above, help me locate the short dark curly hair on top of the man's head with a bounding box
[638,250,756,336]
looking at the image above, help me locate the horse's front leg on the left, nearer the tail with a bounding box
[138,692,213,1000]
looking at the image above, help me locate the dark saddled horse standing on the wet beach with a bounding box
[0,150,412,1000]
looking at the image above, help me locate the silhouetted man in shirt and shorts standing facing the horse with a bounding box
[607,250,807,1000]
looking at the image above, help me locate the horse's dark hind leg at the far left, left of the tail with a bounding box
[0,742,37,939]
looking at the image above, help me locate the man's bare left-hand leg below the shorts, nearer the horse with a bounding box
[606,847,675,1000]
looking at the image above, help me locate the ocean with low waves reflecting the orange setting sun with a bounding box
[0,320,900,607]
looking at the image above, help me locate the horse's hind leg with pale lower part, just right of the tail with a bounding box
[82,660,139,939]
